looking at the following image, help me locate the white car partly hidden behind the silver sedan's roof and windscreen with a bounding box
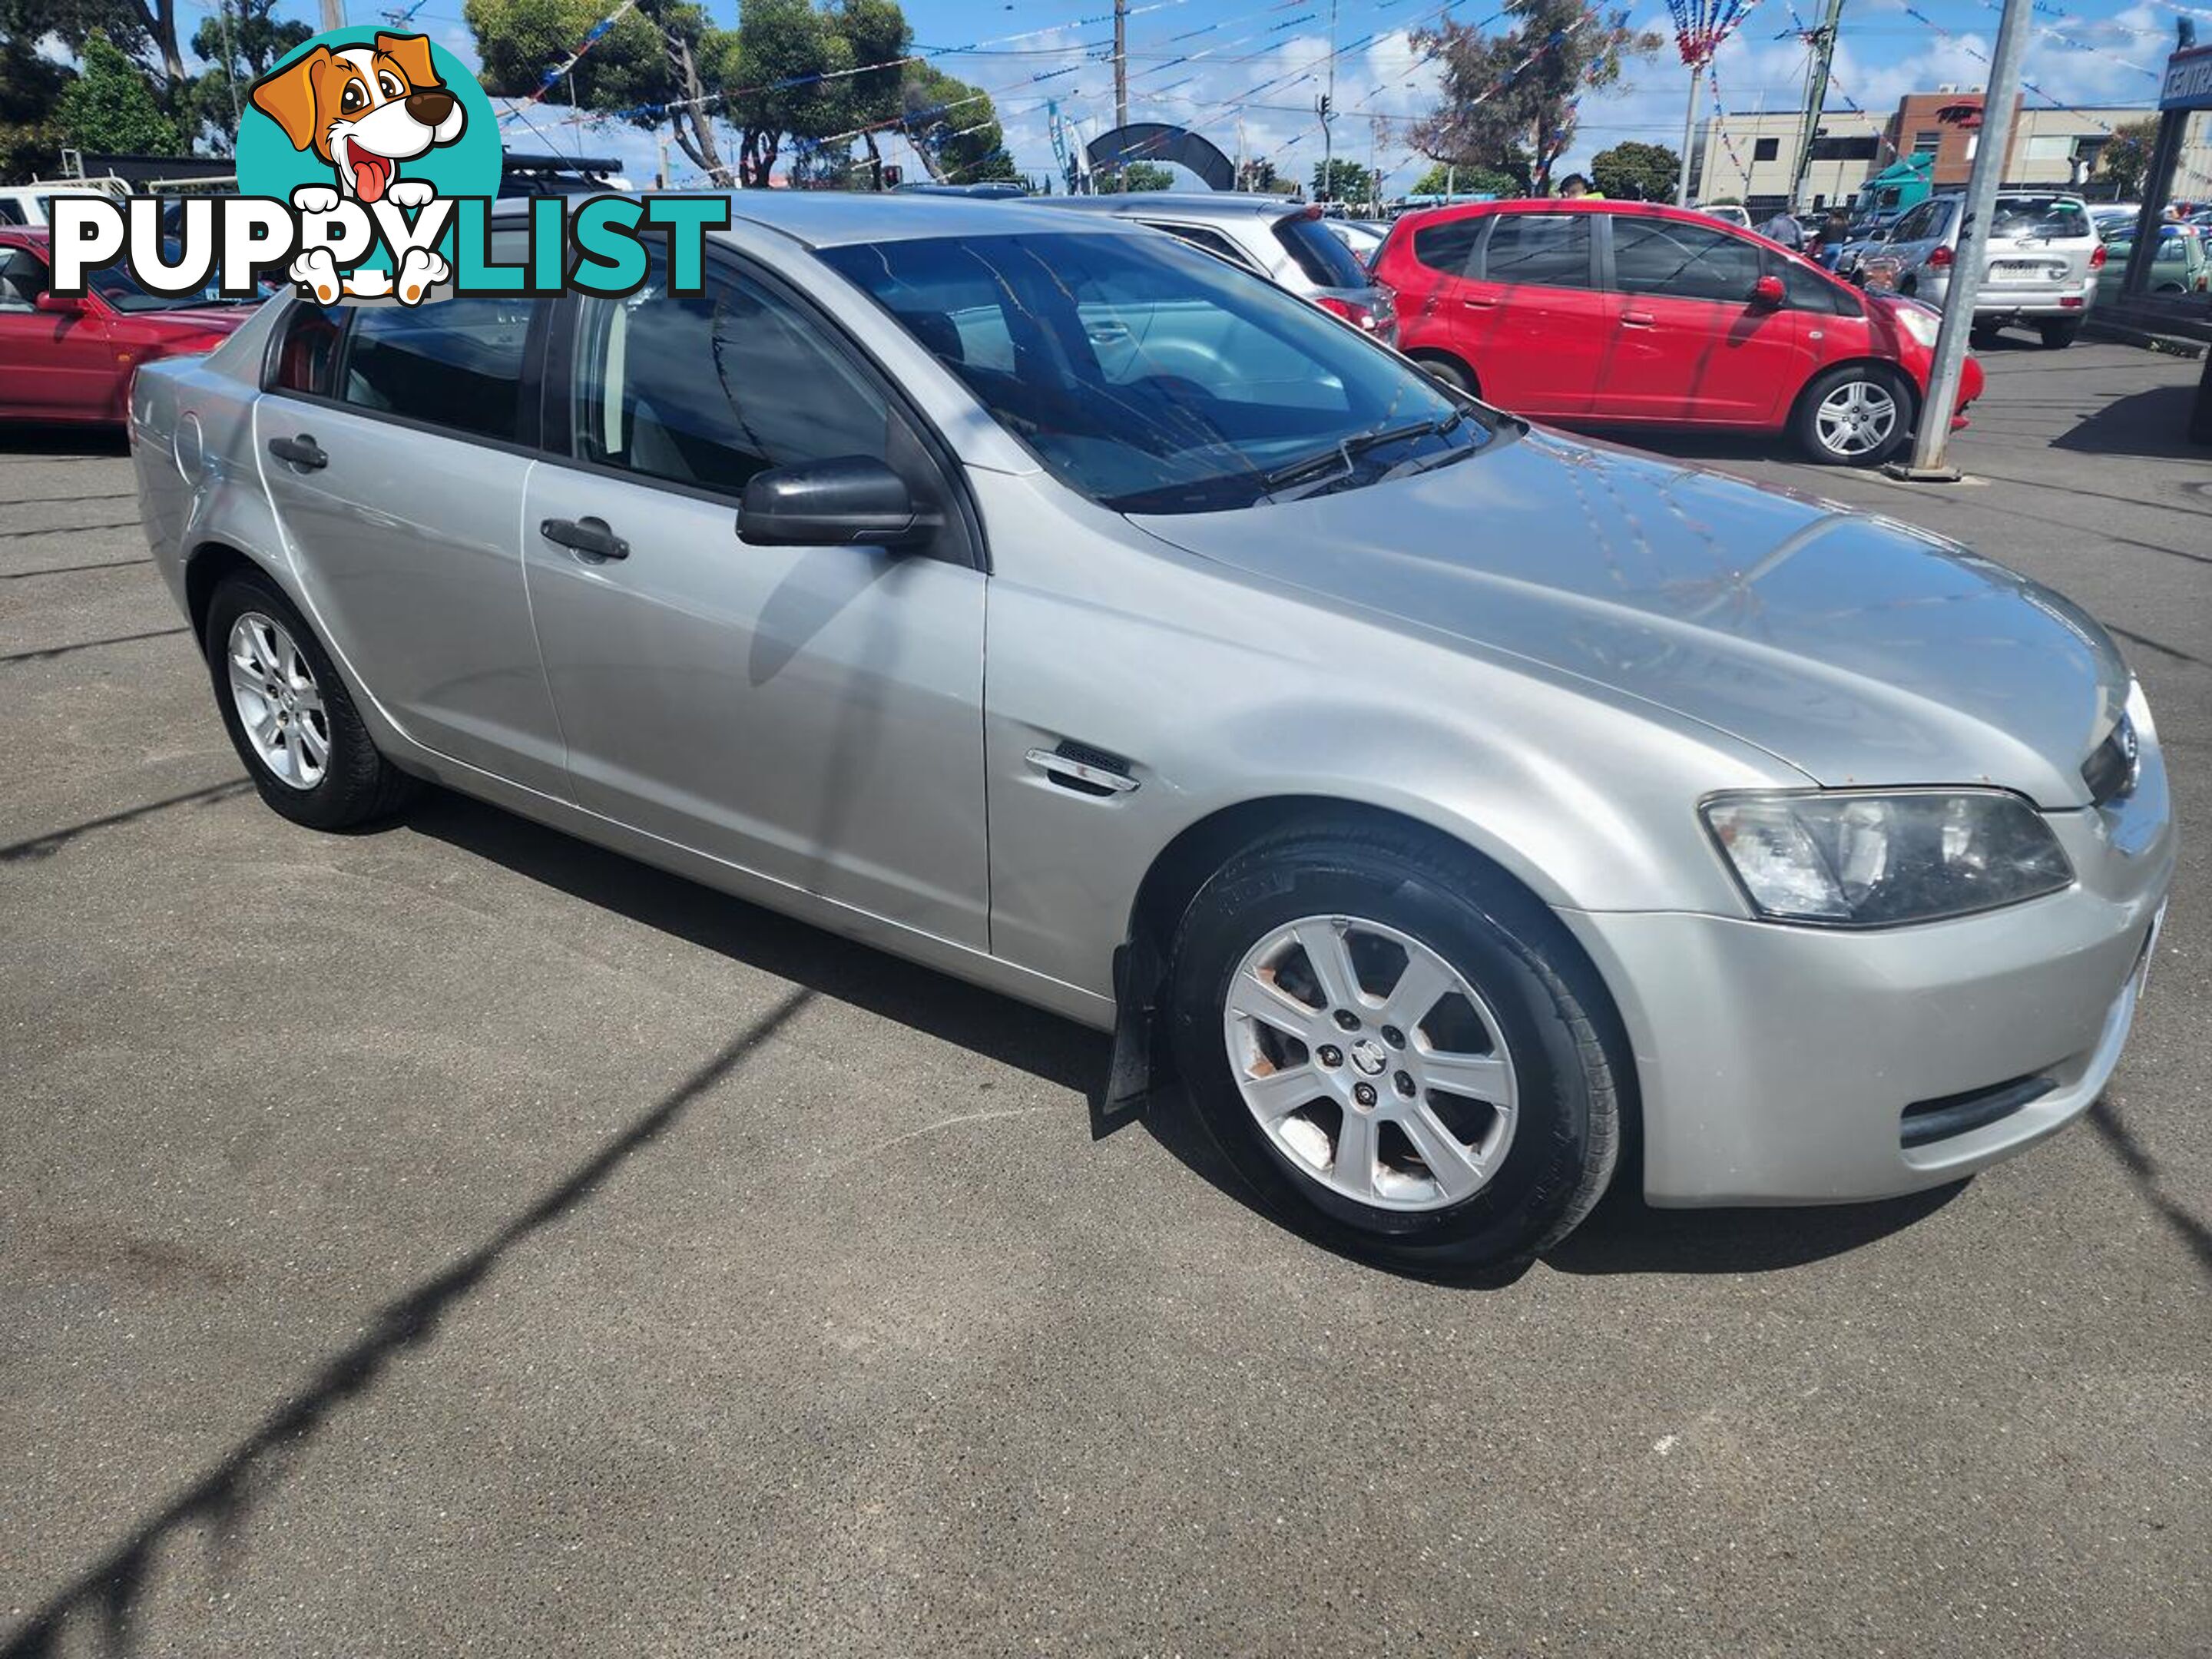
[1035,190,1398,345]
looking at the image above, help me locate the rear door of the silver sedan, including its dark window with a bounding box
[254,285,566,796]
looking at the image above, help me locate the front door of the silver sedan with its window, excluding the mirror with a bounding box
[522,259,986,949]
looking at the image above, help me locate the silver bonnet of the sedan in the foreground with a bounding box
[1133,433,2128,807]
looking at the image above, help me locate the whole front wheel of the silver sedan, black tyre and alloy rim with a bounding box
[1171,827,1619,1277]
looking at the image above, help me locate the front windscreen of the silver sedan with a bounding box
[819,226,1491,513]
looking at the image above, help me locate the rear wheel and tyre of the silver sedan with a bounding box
[201,571,418,830]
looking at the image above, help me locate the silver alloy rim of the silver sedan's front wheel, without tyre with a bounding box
[1221,916,1518,1210]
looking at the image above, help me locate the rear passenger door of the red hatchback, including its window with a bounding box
[1453,212,1613,418]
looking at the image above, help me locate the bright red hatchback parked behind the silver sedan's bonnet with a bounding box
[1373,199,1982,467]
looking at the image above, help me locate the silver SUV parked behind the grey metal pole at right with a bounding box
[1865,190,2106,349]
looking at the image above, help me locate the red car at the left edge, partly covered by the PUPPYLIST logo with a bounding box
[0,226,261,427]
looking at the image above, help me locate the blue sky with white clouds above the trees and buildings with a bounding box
[203,0,2212,190]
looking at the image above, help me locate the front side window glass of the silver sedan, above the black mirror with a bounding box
[573,259,889,493]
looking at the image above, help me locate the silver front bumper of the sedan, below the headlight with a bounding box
[1564,750,2174,1206]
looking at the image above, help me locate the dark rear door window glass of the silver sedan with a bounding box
[339,299,531,442]
